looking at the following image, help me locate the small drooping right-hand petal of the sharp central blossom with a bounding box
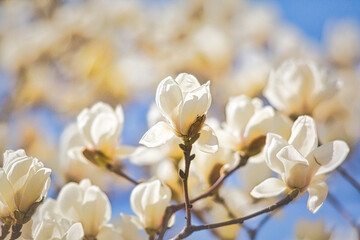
[195,124,219,153]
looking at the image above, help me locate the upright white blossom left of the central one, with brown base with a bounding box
[77,102,132,164]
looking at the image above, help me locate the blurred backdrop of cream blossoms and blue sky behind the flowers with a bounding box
[0,0,360,239]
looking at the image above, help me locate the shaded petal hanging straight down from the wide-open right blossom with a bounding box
[307,181,328,213]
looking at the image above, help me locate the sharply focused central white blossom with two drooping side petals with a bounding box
[140,73,217,152]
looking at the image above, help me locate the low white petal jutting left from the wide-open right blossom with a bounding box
[250,178,287,198]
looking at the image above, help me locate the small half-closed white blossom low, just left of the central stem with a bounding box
[130,179,171,232]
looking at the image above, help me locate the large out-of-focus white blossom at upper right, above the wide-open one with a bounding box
[264,60,340,116]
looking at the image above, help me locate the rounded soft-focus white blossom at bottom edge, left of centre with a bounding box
[57,179,111,239]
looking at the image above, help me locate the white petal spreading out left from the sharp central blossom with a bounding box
[139,121,175,147]
